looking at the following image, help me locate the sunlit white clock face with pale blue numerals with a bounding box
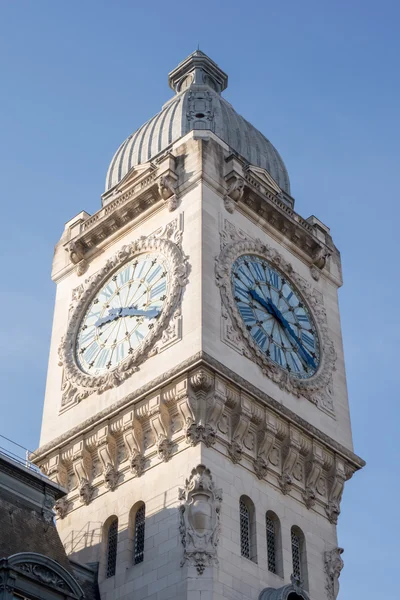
[75,253,170,375]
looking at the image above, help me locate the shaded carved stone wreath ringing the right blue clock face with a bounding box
[215,239,336,403]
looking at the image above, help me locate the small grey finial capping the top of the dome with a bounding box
[168,49,228,94]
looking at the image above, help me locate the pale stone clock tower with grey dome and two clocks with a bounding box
[33,51,364,600]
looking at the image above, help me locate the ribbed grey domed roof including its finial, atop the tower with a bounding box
[106,50,290,194]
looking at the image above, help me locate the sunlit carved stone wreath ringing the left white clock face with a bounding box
[58,236,188,404]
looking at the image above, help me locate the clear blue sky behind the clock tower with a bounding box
[0,0,400,600]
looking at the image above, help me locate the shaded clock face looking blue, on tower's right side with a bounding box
[231,254,320,379]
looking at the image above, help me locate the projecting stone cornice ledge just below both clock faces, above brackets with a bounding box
[29,352,365,471]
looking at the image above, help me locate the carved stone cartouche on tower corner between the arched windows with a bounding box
[179,465,222,575]
